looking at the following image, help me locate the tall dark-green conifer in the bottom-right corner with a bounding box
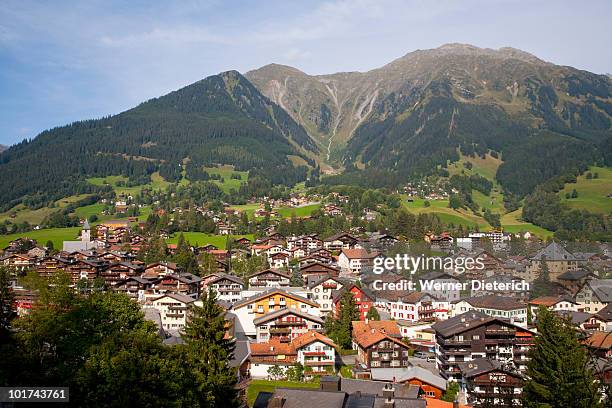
[523,306,601,408]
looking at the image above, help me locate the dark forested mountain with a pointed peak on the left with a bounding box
[0,71,318,209]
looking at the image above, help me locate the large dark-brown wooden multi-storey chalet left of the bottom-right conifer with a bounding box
[432,310,535,381]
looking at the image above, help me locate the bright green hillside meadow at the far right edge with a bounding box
[559,167,612,214]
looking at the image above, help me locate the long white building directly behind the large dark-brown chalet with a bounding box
[450,295,527,327]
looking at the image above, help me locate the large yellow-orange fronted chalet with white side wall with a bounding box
[232,288,320,337]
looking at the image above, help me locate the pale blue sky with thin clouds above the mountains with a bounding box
[0,0,612,145]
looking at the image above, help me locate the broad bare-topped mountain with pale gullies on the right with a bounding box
[245,44,612,196]
